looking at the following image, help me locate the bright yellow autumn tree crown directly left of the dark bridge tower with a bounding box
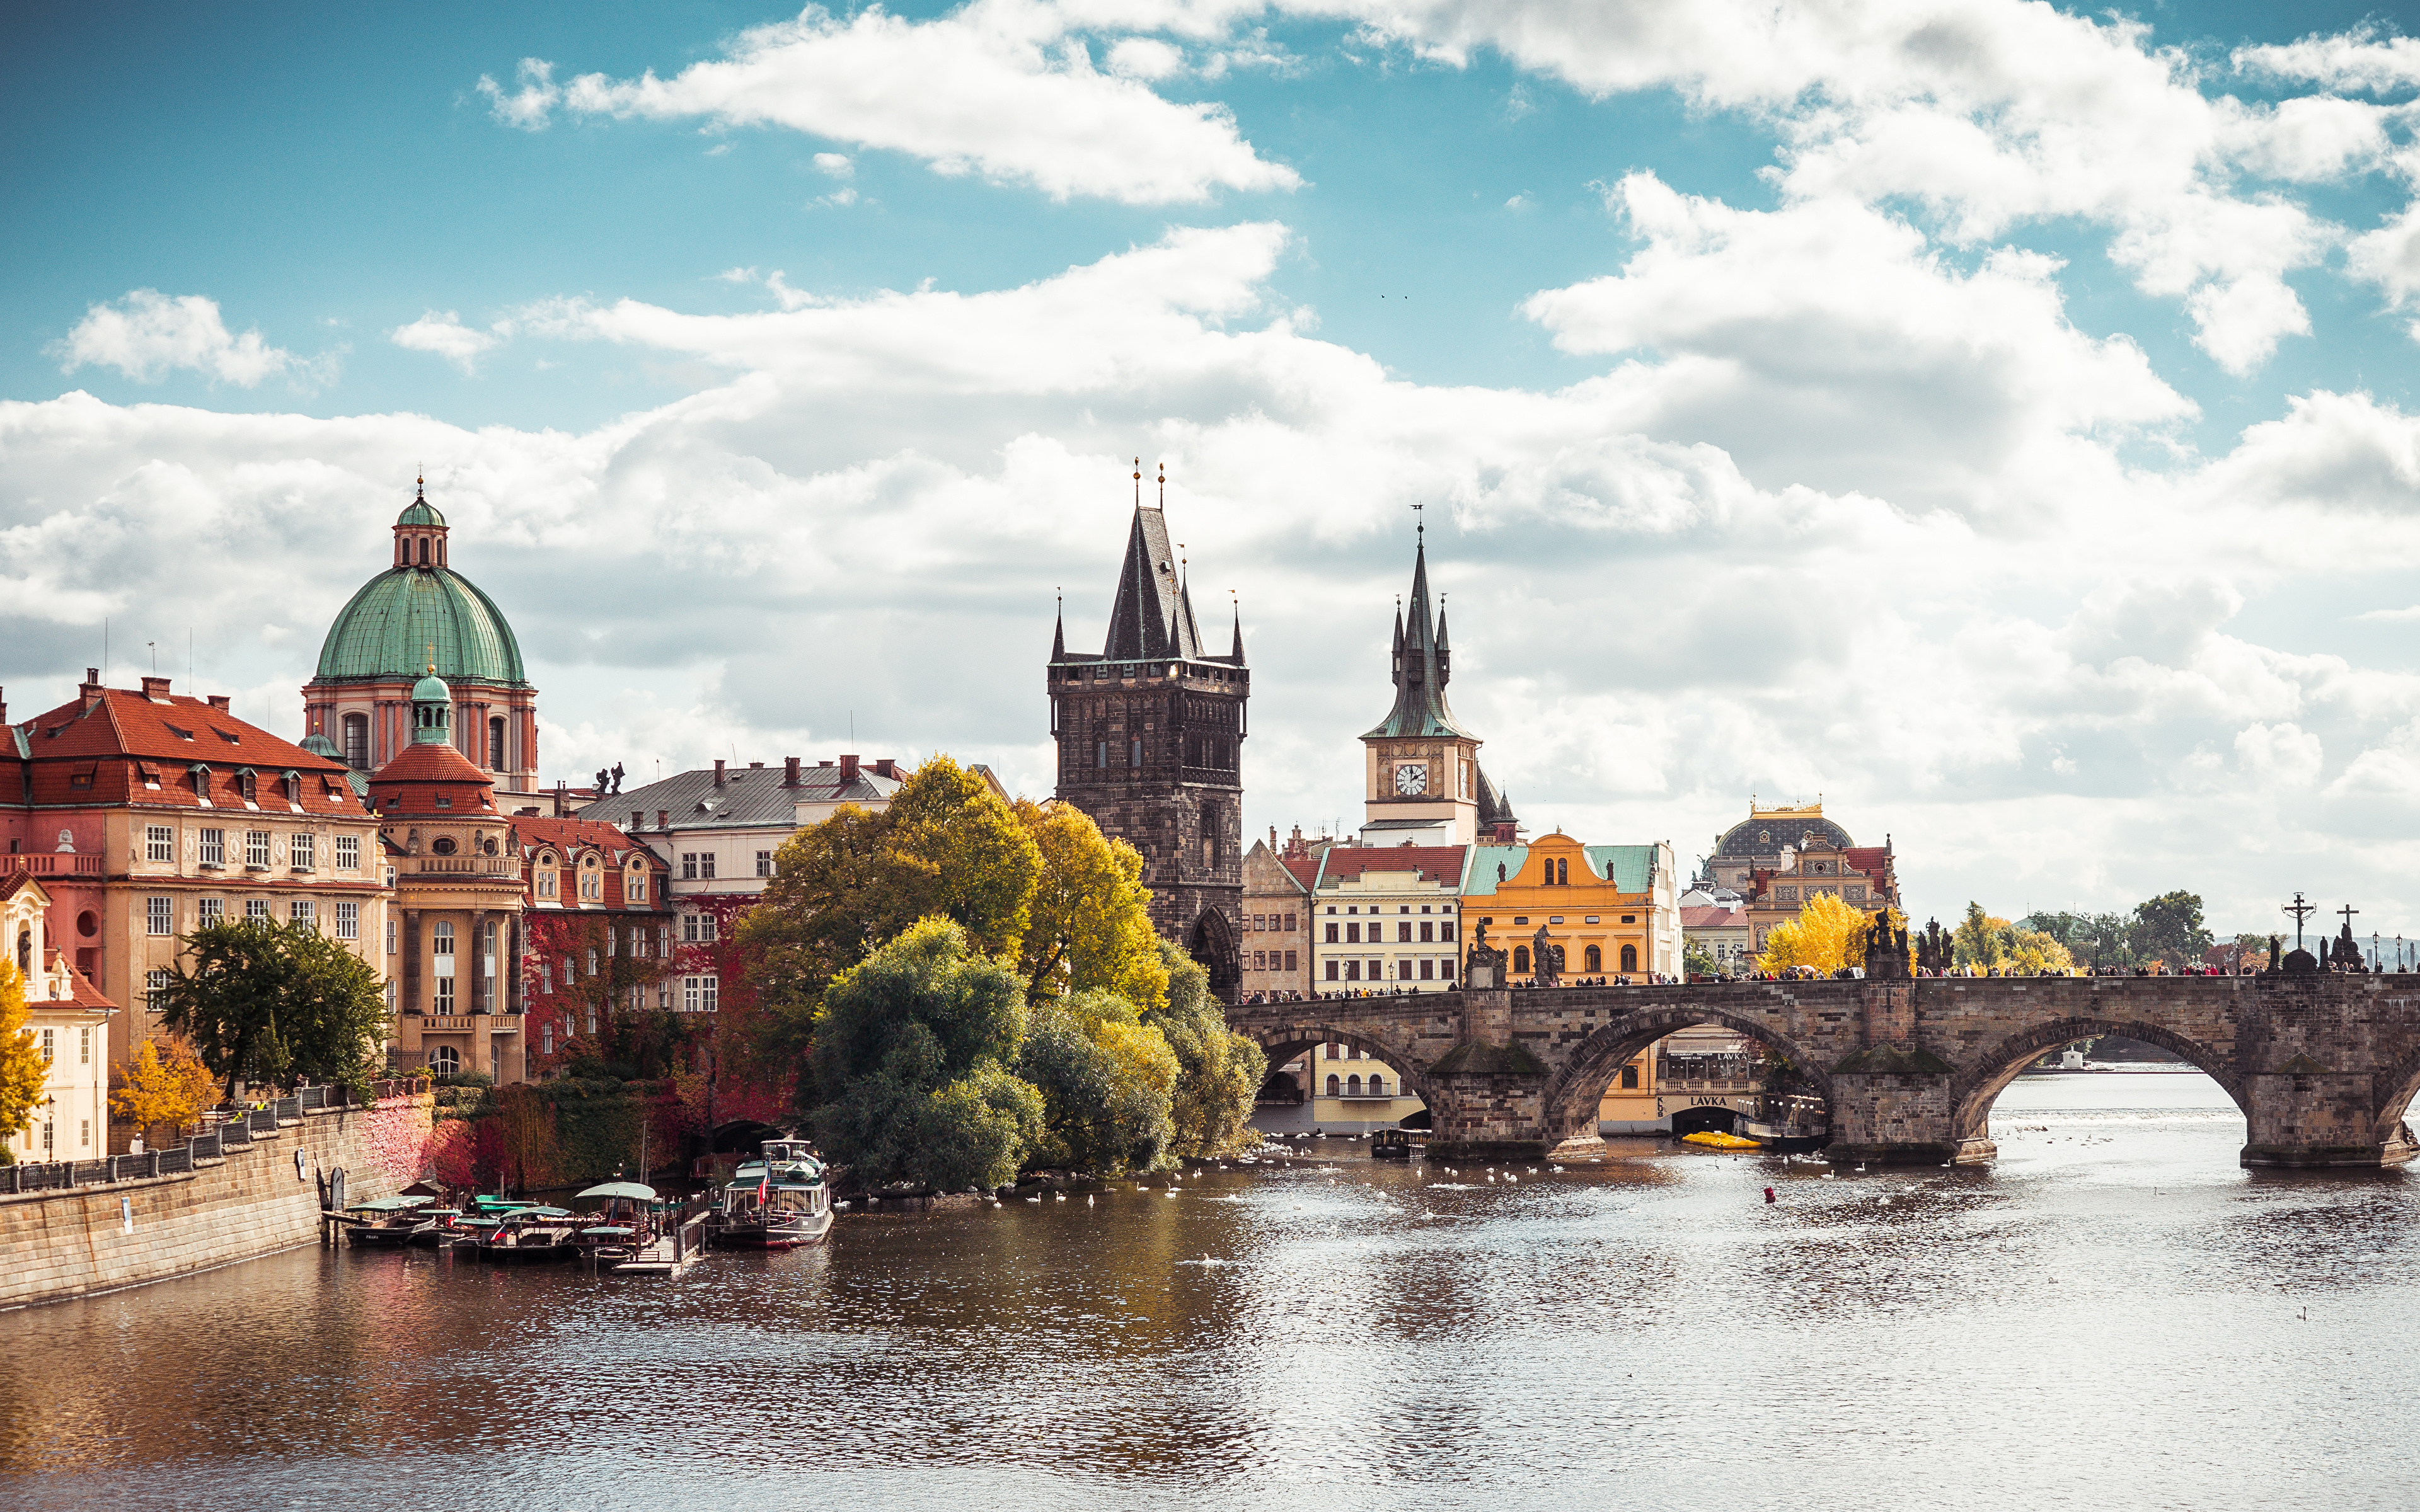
[1017,798,1169,1014]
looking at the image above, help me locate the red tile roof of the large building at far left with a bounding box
[0,687,360,815]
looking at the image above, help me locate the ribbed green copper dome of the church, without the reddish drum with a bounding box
[314,563,527,687]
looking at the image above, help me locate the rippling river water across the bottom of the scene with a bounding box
[0,1074,2420,1512]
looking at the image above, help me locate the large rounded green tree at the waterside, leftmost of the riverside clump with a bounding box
[810,909,1043,1190]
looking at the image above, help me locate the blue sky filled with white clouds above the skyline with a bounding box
[0,0,2420,936]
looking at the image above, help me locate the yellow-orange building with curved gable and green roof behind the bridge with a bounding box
[1461,830,1682,987]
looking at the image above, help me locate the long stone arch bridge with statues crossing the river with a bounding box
[1227,973,2420,1166]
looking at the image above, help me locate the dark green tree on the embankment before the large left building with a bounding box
[159,919,387,1101]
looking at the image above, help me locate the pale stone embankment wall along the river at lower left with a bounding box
[0,1094,431,1309]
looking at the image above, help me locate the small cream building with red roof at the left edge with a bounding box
[0,871,116,1161]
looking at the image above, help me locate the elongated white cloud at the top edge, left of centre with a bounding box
[479,0,1302,205]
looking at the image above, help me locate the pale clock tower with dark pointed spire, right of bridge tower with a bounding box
[1363,527,1512,844]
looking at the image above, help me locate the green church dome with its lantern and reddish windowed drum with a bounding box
[302,481,537,796]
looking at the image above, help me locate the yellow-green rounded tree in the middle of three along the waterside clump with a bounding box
[1017,990,1178,1171]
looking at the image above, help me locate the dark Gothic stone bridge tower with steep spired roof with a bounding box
[1048,462,1251,1002]
